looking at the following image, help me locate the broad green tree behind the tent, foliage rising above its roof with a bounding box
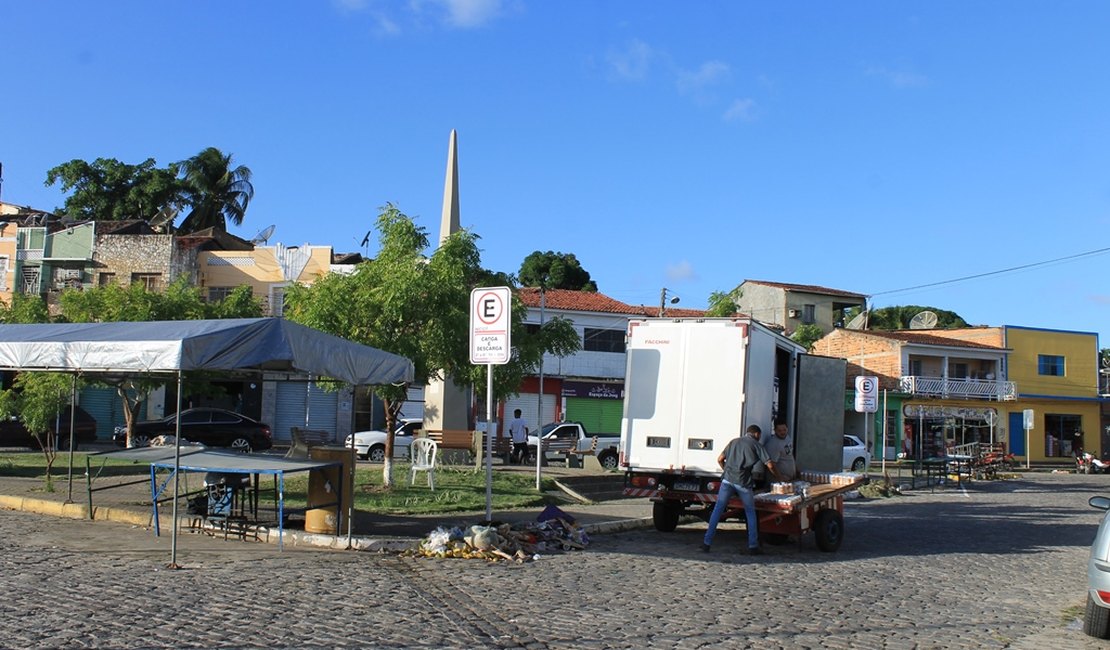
[59,277,262,446]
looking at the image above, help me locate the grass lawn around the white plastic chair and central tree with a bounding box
[273,463,555,515]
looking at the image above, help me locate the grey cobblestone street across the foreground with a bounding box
[0,468,1110,650]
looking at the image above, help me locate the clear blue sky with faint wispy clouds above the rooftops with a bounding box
[0,0,1110,346]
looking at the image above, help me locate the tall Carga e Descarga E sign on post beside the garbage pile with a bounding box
[471,286,513,521]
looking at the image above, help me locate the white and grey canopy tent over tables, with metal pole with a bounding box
[0,318,413,566]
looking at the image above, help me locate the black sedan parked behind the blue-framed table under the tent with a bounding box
[112,408,273,451]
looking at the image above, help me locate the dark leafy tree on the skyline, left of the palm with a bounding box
[44,158,181,221]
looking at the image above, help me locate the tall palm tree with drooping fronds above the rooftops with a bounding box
[178,146,254,233]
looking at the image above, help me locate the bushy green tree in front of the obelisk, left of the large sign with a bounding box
[285,204,577,486]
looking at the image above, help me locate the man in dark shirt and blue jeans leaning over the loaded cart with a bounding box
[702,425,778,556]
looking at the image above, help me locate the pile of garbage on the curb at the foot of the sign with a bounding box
[404,506,589,562]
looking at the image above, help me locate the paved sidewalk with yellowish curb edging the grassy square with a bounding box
[0,456,652,551]
